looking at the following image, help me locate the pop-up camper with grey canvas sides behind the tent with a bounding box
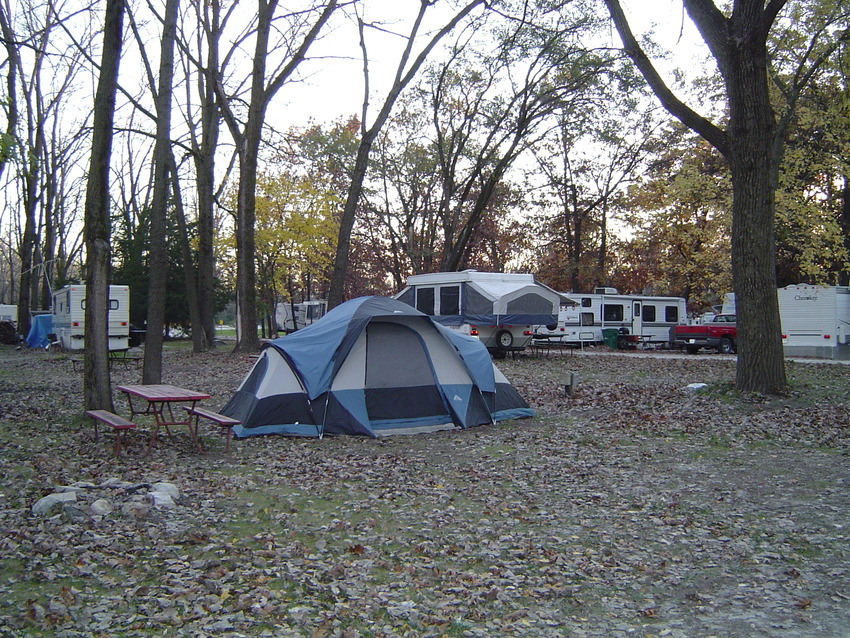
[396,270,568,357]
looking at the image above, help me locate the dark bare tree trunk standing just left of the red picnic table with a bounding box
[83,0,124,411]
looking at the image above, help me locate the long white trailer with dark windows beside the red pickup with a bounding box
[535,288,687,347]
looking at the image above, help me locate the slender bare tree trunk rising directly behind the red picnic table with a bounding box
[142,0,180,383]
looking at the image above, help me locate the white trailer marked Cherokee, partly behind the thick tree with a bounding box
[723,284,850,360]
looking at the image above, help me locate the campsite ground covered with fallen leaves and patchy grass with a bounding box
[0,347,850,638]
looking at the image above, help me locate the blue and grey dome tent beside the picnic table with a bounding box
[221,297,534,437]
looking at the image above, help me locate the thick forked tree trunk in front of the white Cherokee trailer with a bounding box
[605,0,787,394]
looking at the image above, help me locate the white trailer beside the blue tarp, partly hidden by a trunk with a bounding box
[53,284,130,350]
